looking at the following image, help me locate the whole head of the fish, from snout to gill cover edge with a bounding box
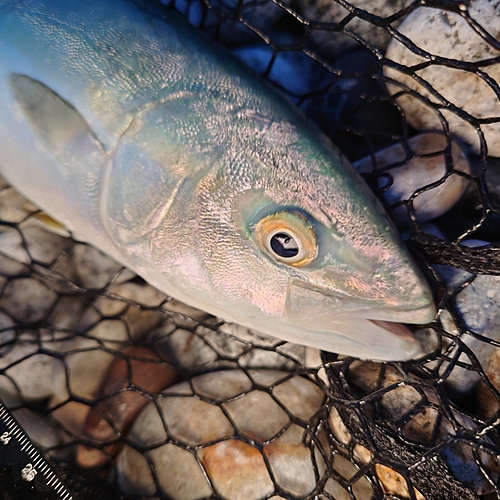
[102,95,435,360]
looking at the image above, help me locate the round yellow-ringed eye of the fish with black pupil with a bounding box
[254,210,318,267]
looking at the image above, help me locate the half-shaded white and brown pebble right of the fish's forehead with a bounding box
[354,132,470,223]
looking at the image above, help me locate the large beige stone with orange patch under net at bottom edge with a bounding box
[117,370,325,500]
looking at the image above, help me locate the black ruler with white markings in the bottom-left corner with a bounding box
[0,403,75,500]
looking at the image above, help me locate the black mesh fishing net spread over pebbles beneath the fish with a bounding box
[0,0,500,500]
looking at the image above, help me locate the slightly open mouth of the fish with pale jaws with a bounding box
[287,280,435,361]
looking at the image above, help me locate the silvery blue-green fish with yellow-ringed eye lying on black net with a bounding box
[0,0,435,360]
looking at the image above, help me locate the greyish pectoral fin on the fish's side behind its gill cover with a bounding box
[9,73,103,157]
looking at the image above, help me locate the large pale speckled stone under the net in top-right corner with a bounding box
[384,0,500,156]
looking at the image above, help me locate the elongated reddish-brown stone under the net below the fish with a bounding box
[76,346,177,468]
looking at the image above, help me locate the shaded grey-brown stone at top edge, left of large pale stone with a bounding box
[299,0,410,58]
